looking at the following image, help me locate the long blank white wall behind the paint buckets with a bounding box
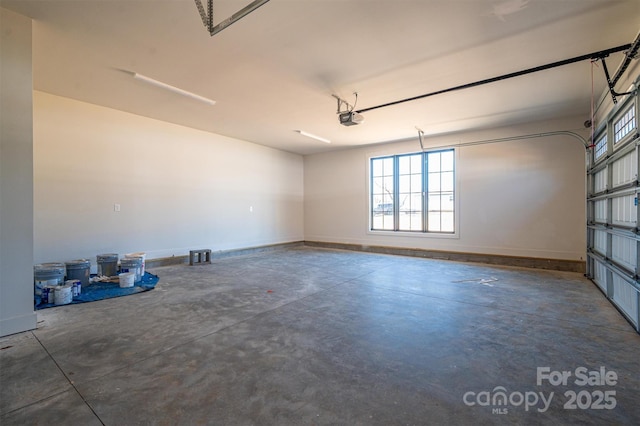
[34,91,304,267]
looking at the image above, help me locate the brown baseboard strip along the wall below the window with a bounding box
[304,241,587,273]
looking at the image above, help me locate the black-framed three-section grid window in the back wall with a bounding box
[370,149,455,233]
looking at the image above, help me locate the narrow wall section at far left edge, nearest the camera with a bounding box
[0,8,36,336]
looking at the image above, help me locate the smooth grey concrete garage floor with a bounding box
[0,246,640,426]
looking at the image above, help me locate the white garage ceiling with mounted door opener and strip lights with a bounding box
[0,0,640,154]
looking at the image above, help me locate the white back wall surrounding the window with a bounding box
[304,118,586,260]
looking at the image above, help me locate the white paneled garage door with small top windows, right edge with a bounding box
[587,85,640,332]
